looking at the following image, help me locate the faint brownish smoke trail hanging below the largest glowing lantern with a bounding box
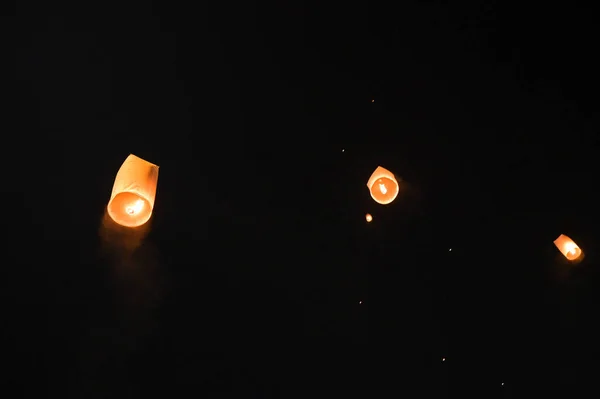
[72,212,165,393]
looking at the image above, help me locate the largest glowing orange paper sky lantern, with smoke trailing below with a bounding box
[107,154,158,227]
